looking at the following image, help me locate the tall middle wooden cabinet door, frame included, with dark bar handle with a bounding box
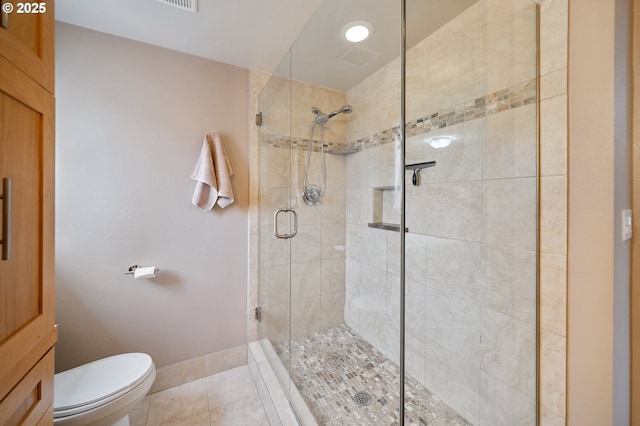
[0,57,56,400]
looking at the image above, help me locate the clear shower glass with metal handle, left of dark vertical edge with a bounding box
[259,0,403,425]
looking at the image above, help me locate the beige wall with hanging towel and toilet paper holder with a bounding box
[56,23,249,370]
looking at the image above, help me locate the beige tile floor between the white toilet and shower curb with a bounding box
[129,365,269,426]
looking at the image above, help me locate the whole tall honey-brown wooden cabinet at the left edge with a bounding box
[0,2,57,425]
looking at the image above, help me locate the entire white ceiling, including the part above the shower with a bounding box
[55,0,477,91]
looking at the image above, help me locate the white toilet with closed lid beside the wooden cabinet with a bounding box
[53,353,156,426]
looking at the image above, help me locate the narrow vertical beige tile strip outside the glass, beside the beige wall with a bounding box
[538,0,569,425]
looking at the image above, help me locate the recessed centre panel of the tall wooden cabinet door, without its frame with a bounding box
[0,93,42,342]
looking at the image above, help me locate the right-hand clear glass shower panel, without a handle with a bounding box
[404,0,538,426]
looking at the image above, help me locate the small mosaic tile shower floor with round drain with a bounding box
[274,324,470,426]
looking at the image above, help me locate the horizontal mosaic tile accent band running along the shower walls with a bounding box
[260,79,538,155]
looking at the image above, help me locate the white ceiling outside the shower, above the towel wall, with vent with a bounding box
[55,0,320,72]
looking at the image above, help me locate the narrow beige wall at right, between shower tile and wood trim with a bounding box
[567,0,629,425]
